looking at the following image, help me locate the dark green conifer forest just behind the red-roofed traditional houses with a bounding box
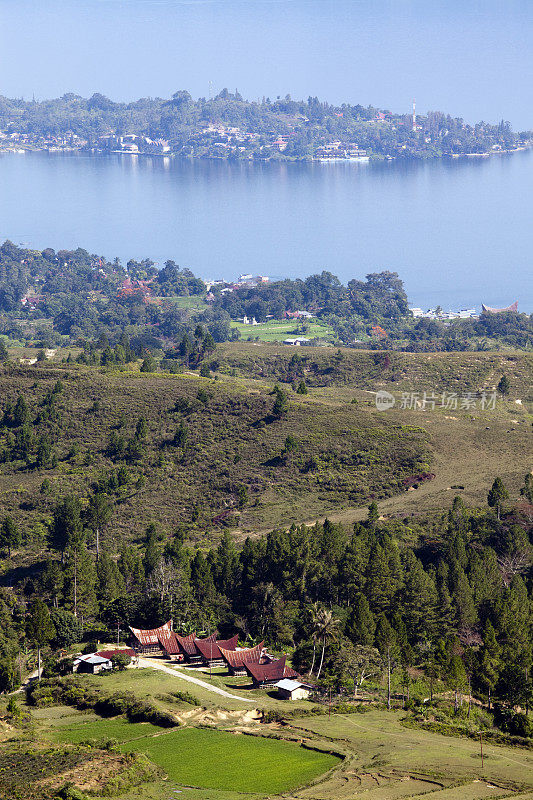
[0,468,533,720]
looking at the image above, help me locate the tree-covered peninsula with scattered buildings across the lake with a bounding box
[0,89,529,159]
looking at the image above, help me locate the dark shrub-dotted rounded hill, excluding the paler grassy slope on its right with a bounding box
[0,360,429,548]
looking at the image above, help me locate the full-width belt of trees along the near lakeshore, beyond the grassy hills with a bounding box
[0,241,533,354]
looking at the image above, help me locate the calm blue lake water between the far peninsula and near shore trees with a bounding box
[0,151,533,313]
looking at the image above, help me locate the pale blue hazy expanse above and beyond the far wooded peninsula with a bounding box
[0,0,533,130]
